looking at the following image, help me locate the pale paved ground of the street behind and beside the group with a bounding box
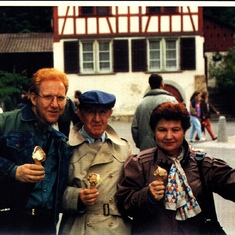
[110,121,235,235]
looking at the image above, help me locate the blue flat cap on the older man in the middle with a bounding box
[78,90,116,109]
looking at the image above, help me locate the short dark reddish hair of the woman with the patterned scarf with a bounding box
[150,102,190,132]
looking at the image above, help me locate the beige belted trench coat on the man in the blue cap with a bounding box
[60,126,132,235]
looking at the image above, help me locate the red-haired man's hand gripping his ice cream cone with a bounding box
[15,164,45,183]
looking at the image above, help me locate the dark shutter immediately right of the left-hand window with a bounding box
[113,40,129,72]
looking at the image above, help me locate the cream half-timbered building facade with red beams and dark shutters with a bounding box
[53,2,205,117]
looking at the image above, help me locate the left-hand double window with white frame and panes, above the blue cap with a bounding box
[80,40,112,74]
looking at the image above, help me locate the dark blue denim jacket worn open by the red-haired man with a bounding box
[0,105,69,224]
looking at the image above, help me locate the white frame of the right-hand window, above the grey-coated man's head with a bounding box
[147,38,180,72]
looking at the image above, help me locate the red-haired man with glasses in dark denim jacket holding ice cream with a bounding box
[0,68,69,235]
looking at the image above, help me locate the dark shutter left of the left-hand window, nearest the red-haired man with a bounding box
[64,41,79,73]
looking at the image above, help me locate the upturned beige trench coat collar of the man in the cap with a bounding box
[69,123,127,146]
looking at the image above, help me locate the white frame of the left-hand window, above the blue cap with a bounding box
[79,40,113,74]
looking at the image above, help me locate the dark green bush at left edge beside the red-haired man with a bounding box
[0,70,29,111]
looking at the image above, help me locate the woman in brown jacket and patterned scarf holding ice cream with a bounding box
[116,102,235,235]
